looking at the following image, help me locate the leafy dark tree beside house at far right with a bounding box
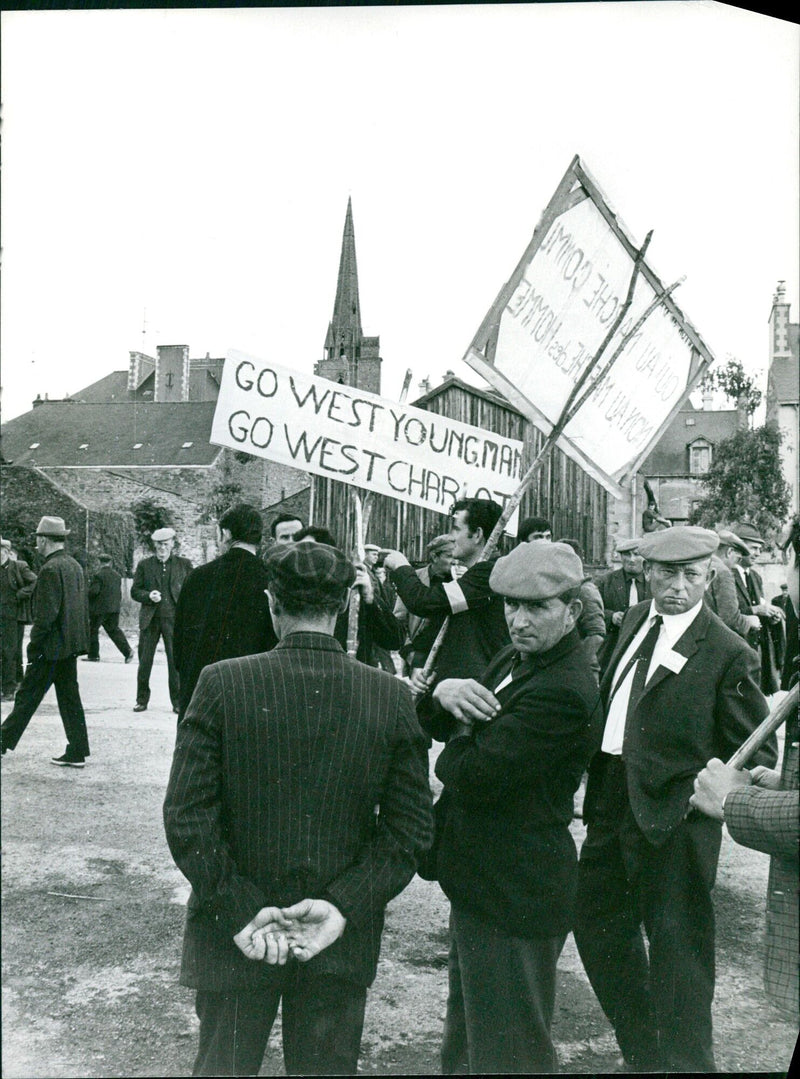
[690,424,789,537]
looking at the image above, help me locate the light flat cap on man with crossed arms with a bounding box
[489,540,585,600]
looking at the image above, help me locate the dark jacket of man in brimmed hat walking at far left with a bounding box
[28,550,89,659]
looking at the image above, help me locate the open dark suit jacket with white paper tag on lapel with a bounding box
[583,601,777,845]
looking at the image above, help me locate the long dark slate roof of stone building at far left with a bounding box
[2,397,220,468]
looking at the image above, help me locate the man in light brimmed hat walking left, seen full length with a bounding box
[2,517,89,768]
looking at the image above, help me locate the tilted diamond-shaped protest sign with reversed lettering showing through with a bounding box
[464,158,714,495]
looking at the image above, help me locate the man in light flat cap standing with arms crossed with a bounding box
[425,541,602,1075]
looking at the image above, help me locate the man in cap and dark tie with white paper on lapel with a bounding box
[574,527,776,1071]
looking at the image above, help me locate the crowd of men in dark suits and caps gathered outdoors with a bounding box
[0,498,800,1075]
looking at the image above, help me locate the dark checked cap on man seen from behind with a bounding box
[266,543,355,604]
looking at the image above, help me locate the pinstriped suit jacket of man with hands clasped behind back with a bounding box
[164,633,432,991]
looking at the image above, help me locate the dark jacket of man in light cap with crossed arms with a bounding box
[429,630,602,938]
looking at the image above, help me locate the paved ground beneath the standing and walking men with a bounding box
[2,637,797,1079]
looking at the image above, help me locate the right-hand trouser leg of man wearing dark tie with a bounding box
[640,817,721,1071]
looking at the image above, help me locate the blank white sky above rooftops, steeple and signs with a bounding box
[2,0,800,420]
